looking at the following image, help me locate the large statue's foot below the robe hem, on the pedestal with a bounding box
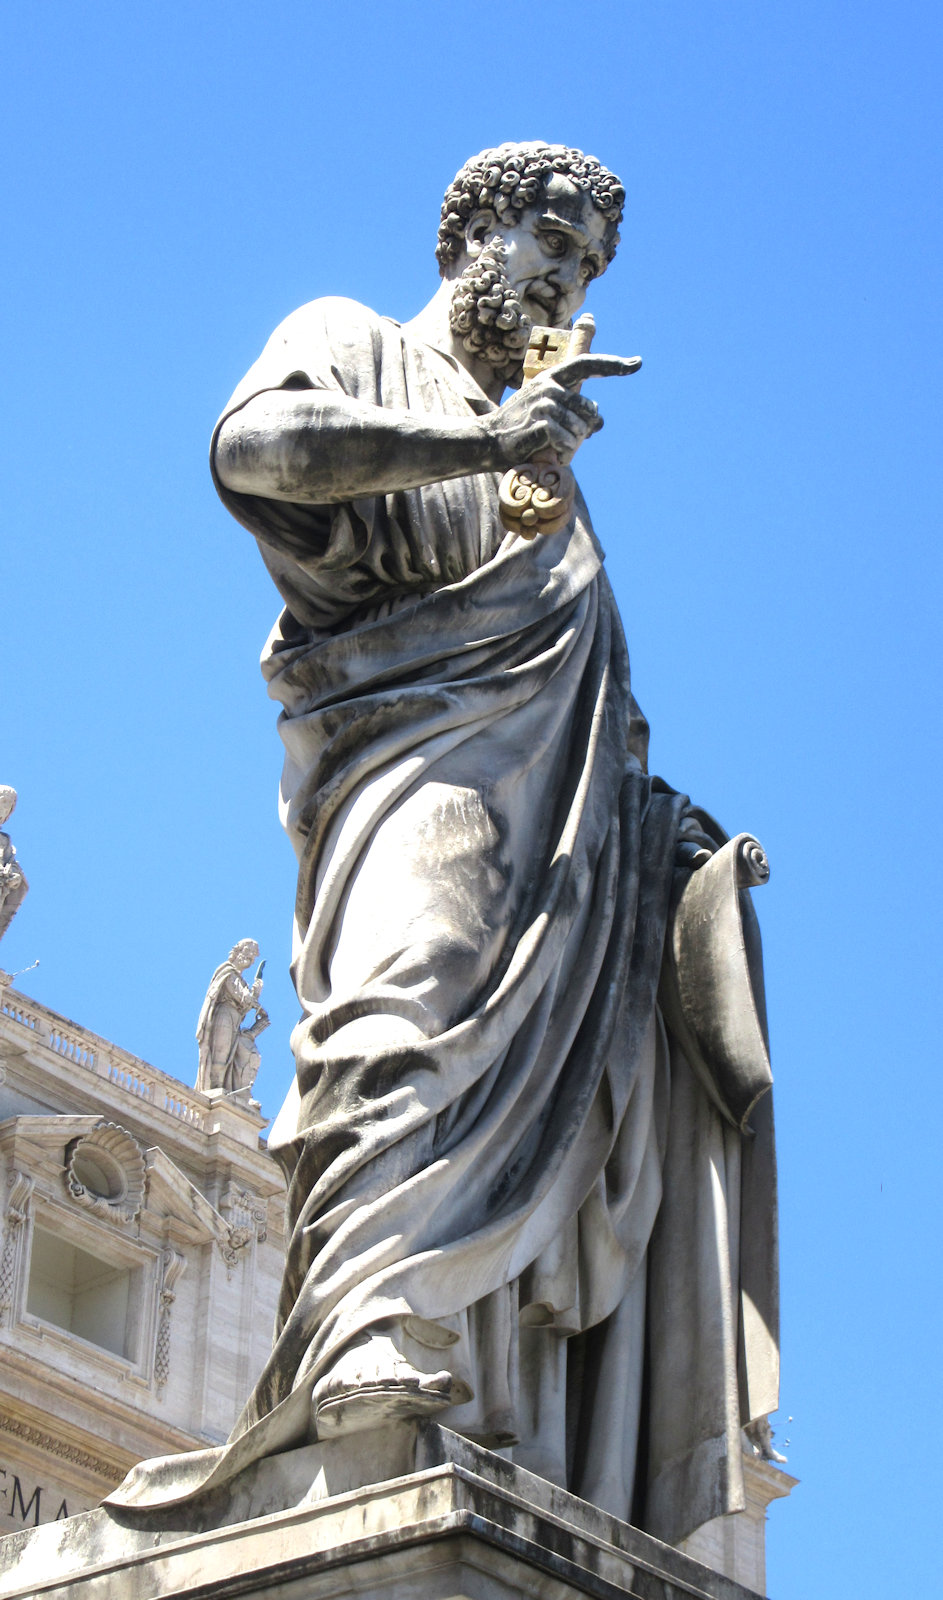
[314,1333,467,1438]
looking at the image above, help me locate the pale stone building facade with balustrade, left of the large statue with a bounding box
[0,986,285,1533]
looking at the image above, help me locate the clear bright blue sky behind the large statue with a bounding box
[0,0,943,1600]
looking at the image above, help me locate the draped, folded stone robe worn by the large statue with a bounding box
[108,299,776,1542]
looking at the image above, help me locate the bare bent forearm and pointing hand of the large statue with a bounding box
[215,357,634,506]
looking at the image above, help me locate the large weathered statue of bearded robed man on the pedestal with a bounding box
[112,144,778,1542]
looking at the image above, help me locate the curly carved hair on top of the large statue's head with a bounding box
[435,142,626,277]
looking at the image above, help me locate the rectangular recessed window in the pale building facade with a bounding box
[26,1227,141,1362]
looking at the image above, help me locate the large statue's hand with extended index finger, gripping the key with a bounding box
[484,354,642,467]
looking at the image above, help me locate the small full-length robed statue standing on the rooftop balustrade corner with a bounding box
[197,939,269,1094]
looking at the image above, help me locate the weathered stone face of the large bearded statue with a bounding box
[480,174,607,328]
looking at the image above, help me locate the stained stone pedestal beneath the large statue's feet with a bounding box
[0,1422,768,1600]
